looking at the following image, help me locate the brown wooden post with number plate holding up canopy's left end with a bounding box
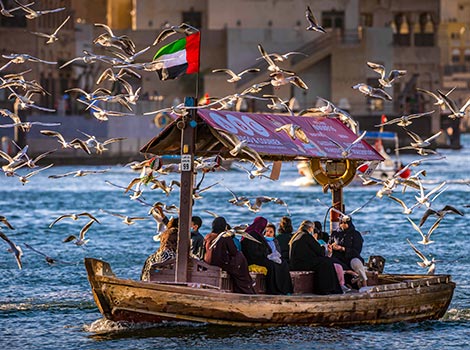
[175,97,196,282]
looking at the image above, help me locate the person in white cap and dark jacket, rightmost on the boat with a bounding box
[328,216,367,287]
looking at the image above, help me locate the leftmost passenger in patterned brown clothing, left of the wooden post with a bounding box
[140,218,178,281]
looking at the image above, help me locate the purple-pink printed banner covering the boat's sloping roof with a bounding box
[198,109,383,161]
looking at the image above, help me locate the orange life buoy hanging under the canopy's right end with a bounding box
[309,158,357,188]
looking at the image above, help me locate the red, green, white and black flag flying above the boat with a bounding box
[153,32,200,80]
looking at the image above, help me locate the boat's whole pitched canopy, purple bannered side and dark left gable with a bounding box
[140,109,384,161]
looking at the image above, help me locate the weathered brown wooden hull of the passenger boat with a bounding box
[85,259,455,326]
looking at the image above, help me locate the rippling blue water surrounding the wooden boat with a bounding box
[0,135,470,349]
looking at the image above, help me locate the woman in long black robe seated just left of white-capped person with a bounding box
[289,220,343,294]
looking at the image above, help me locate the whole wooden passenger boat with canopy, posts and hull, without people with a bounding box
[85,104,455,326]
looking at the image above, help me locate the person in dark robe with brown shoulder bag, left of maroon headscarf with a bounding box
[204,216,255,294]
